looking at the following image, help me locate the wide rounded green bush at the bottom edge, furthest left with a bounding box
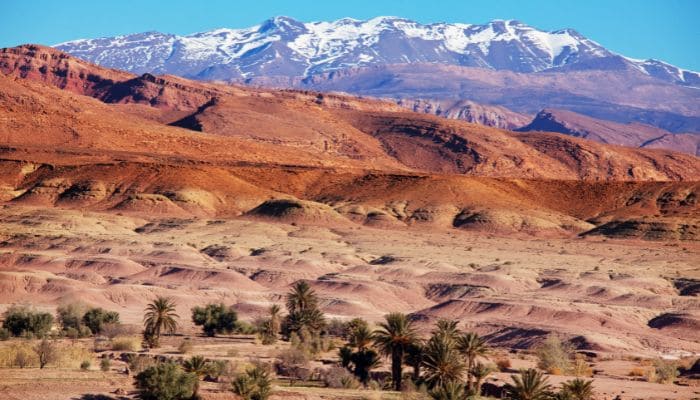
[136,362,197,400]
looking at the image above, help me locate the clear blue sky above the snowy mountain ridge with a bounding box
[0,0,700,71]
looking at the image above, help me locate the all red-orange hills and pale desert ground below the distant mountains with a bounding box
[0,45,700,399]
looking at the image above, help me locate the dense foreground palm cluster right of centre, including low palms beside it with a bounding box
[339,313,593,400]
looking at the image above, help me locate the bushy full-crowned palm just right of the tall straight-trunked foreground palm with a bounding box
[423,334,465,387]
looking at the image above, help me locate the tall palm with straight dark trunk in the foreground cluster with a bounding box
[374,313,417,391]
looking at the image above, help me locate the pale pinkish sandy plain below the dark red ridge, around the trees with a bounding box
[0,206,700,399]
